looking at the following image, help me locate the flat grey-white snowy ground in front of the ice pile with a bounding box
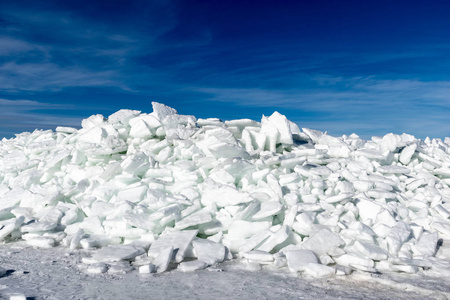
[0,243,450,300]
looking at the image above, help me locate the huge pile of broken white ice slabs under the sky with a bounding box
[0,103,450,277]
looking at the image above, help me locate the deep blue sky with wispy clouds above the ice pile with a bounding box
[0,0,450,138]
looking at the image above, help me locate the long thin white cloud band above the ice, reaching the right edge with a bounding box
[192,75,450,112]
